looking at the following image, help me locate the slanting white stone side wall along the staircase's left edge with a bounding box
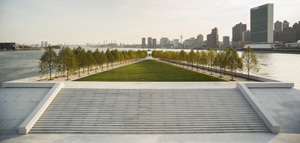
[19,83,64,135]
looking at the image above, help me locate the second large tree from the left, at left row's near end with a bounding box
[65,47,76,80]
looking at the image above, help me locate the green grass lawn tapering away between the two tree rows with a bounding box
[76,60,224,81]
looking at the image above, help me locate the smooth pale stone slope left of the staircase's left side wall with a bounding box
[0,88,50,135]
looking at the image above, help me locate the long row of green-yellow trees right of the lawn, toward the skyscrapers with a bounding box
[152,47,258,80]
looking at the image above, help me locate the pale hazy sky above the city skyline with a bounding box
[0,0,300,45]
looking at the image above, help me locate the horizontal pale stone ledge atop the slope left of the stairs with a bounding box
[2,82,56,88]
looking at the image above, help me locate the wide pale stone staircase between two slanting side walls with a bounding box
[30,88,269,134]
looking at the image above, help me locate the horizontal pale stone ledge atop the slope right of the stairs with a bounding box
[244,82,294,88]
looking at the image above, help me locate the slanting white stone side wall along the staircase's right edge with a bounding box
[237,83,280,133]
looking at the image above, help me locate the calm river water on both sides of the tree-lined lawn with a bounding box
[0,47,300,89]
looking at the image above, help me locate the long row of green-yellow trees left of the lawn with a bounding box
[39,47,148,80]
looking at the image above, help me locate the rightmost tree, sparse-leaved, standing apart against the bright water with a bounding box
[242,46,258,80]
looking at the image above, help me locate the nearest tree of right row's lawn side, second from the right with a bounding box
[226,47,239,81]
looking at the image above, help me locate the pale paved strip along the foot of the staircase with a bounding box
[0,133,300,143]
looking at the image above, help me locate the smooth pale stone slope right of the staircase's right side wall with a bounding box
[250,88,300,134]
